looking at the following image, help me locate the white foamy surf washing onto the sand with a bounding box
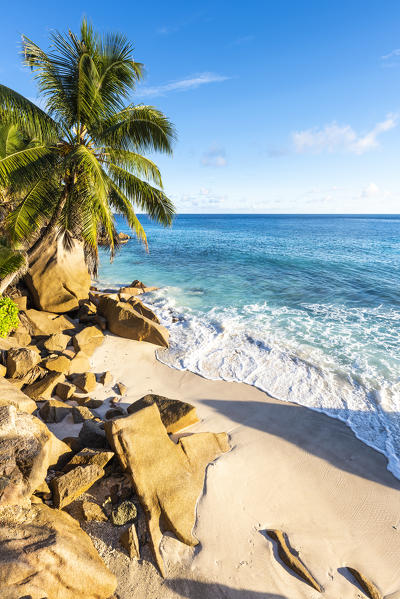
[144,288,400,478]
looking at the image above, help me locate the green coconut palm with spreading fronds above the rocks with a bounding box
[0,20,175,292]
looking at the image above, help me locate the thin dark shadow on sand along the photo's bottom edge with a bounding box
[164,578,285,599]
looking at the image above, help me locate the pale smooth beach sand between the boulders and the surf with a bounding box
[52,335,400,599]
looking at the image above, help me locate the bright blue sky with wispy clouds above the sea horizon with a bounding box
[0,0,400,213]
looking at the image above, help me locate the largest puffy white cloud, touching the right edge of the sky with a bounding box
[292,114,398,154]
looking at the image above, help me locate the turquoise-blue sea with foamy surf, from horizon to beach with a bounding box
[99,214,400,478]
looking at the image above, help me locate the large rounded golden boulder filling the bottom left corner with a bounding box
[0,504,117,599]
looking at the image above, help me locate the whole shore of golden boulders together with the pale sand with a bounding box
[0,280,400,599]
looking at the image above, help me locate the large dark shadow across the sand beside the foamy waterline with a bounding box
[199,398,400,491]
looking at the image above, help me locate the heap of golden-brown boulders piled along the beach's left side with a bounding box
[0,281,229,599]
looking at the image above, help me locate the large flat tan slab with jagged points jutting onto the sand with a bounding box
[104,403,230,575]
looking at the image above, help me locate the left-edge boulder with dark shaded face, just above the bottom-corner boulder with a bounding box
[0,406,69,506]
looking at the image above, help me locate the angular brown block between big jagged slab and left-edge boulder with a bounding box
[50,464,104,509]
